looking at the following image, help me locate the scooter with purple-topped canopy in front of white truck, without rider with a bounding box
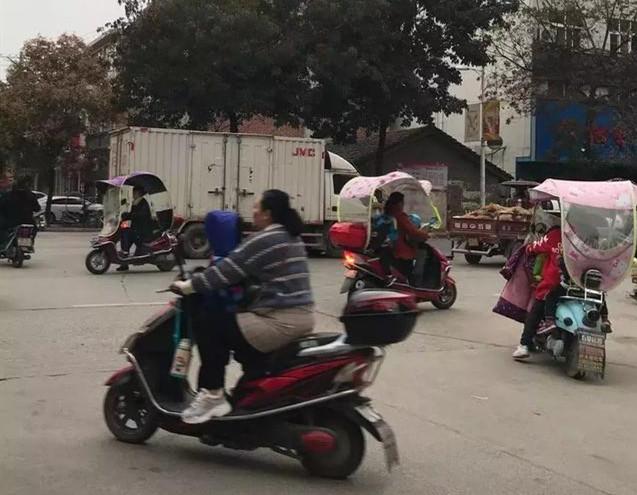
[85,172,177,275]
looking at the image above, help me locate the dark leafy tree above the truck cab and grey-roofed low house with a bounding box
[302,0,517,172]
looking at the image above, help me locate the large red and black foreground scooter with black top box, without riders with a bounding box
[104,215,412,479]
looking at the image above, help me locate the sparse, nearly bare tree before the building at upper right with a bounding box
[492,0,637,159]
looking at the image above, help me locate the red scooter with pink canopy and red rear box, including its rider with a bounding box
[330,172,457,309]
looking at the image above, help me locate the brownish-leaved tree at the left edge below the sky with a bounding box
[0,35,111,202]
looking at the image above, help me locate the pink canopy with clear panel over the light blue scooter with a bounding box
[530,179,637,291]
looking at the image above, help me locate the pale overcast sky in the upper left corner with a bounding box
[0,0,123,79]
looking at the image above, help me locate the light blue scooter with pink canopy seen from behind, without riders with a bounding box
[530,179,637,379]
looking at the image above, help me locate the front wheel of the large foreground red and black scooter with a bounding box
[104,379,158,443]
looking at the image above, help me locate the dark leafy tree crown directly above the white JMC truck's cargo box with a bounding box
[112,0,308,132]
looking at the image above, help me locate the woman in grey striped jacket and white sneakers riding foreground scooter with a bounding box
[171,189,314,424]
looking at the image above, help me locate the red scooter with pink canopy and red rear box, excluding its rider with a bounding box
[330,172,458,309]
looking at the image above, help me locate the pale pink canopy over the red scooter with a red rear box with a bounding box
[339,172,433,223]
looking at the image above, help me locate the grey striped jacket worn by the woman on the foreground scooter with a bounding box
[192,224,314,309]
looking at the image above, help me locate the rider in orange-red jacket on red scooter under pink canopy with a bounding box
[383,192,429,278]
